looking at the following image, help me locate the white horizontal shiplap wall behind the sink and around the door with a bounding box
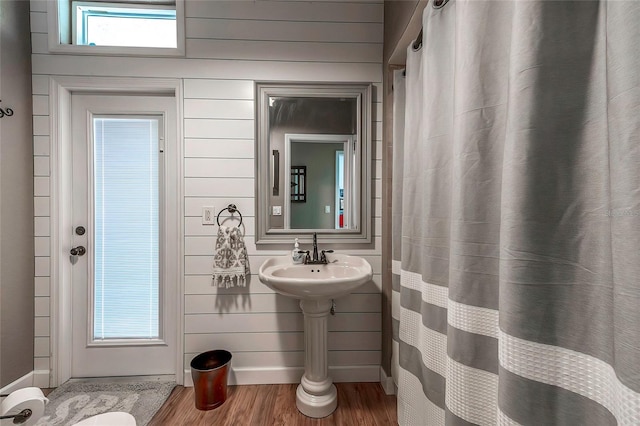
[31,0,383,386]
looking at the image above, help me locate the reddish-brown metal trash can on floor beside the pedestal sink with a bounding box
[191,349,231,410]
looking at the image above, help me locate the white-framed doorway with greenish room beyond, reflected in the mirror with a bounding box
[284,134,354,229]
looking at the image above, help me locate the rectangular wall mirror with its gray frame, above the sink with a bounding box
[256,83,373,244]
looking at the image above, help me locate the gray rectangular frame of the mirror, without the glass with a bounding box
[255,82,373,248]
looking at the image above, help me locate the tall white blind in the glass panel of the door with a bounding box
[93,116,161,340]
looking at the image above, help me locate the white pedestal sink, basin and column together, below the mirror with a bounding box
[258,254,373,418]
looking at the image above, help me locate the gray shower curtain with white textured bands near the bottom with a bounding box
[393,0,640,426]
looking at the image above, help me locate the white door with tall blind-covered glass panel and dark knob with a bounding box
[68,94,178,377]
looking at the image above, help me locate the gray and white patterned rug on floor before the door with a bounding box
[35,381,176,426]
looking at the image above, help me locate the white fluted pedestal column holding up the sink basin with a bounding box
[296,300,338,418]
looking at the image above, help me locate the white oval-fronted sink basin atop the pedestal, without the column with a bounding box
[258,254,373,300]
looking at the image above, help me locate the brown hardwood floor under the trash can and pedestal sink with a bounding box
[149,383,398,426]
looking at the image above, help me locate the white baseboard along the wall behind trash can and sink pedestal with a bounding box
[184,365,380,387]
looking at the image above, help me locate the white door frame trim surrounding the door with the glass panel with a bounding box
[49,77,184,387]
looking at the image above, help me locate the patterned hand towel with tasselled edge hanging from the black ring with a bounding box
[213,226,249,288]
